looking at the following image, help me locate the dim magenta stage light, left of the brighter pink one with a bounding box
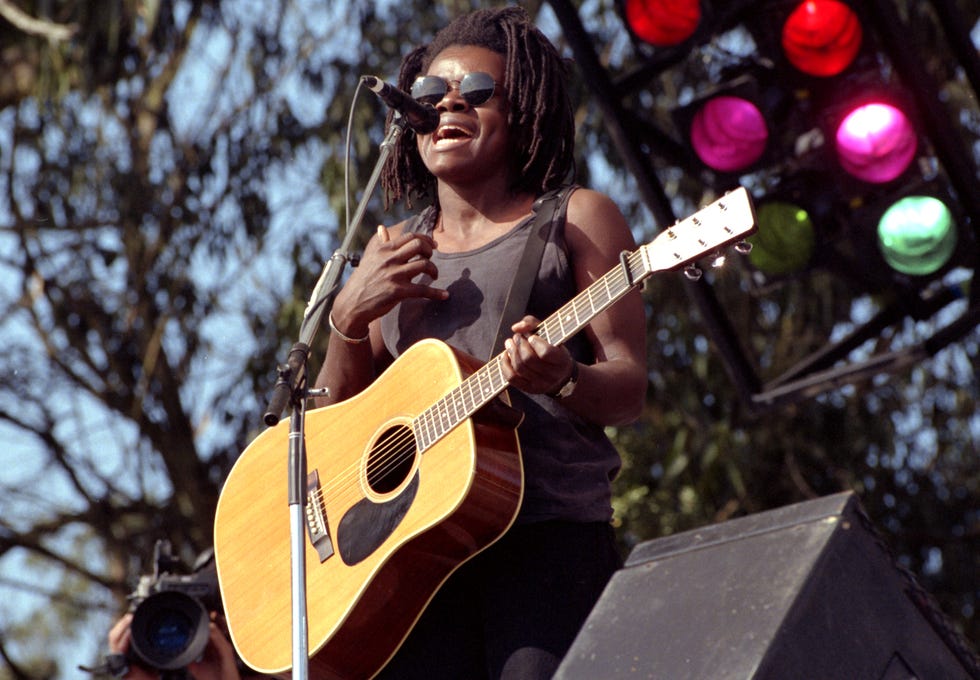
[691,95,769,172]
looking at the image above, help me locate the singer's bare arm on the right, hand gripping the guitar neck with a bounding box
[503,189,647,425]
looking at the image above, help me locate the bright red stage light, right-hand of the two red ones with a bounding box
[782,0,863,77]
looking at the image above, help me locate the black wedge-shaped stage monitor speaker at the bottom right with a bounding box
[555,492,980,680]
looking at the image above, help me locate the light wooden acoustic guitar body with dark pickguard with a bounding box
[214,340,523,678]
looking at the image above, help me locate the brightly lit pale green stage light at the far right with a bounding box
[878,196,956,276]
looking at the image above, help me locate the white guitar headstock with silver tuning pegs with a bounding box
[640,187,757,272]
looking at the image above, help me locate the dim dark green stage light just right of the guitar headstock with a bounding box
[749,200,816,276]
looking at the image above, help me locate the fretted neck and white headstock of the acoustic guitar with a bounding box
[413,187,755,451]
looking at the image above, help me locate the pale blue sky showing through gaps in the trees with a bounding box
[0,0,980,678]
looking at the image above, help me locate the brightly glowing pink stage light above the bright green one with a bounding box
[835,102,918,184]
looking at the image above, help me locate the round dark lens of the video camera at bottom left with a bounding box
[130,591,209,670]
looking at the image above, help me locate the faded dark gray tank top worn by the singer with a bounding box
[381,194,620,522]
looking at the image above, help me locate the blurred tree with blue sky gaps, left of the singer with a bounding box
[0,0,462,677]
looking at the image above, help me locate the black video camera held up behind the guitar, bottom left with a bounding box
[129,540,221,679]
